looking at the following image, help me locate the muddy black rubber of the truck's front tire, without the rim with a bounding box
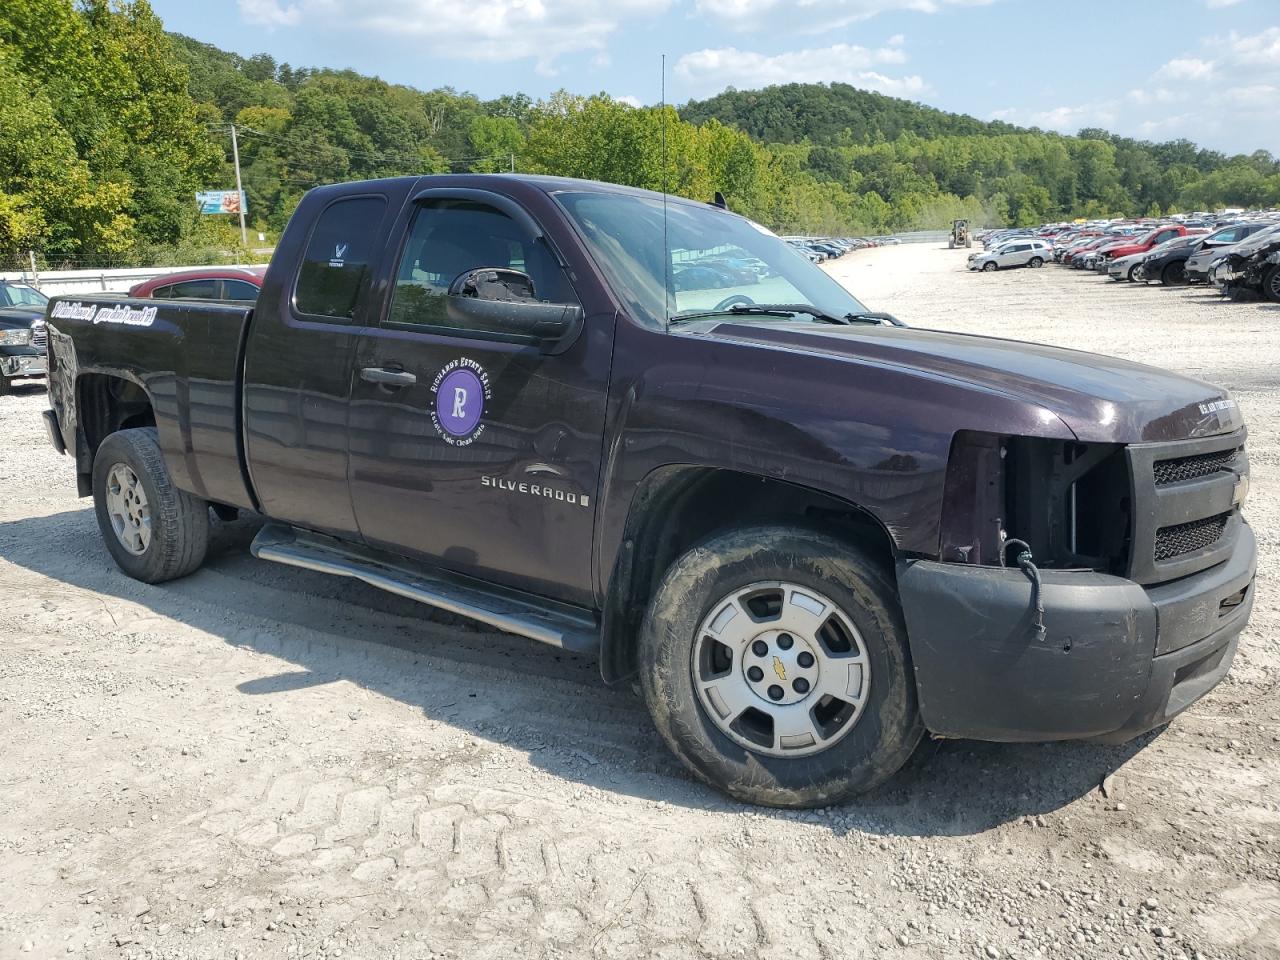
[639,526,924,808]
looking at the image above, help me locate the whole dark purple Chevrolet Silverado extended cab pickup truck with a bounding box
[46,175,1256,806]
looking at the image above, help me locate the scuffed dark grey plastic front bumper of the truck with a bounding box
[897,525,1257,742]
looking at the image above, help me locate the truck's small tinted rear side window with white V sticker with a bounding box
[293,197,387,320]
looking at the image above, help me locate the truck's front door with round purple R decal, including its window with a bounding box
[349,191,613,605]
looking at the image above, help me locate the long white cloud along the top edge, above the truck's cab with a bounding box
[238,0,673,74]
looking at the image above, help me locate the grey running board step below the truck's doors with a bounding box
[250,524,600,653]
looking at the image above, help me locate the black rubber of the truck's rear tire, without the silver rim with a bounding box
[93,426,209,584]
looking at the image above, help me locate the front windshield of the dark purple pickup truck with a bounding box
[556,192,867,326]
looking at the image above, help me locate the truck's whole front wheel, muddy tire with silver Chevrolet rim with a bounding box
[639,526,924,808]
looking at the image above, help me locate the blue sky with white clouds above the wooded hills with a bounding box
[151,0,1280,155]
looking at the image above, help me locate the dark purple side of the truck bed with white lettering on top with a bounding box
[46,296,255,508]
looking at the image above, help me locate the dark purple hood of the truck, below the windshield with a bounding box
[707,321,1243,443]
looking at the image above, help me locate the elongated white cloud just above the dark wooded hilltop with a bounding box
[675,44,928,97]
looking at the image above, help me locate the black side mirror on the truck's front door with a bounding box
[445,268,582,353]
